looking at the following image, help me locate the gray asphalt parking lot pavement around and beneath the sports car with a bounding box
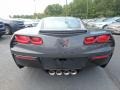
[0,36,120,90]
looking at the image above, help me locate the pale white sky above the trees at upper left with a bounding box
[0,0,73,17]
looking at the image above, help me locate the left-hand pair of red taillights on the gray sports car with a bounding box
[15,35,43,45]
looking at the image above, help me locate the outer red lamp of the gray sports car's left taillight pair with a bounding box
[15,35,30,44]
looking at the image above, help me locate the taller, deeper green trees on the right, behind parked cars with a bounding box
[63,0,120,18]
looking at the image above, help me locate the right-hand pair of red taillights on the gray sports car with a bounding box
[84,34,110,45]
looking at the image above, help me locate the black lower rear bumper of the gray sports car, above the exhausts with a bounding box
[12,49,112,70]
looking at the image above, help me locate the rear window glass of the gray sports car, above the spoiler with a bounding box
[42,18,81,30]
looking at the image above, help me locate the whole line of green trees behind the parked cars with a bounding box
[14,0,120,18]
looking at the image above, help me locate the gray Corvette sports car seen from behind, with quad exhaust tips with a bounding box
[10,17,115,75]
